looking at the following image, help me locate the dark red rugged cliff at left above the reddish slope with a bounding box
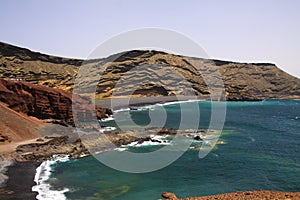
[0,79,111,125]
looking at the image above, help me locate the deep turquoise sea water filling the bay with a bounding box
[40,100,300,200]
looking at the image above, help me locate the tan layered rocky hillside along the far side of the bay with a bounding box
[0,43,300,100]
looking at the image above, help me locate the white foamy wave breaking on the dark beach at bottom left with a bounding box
[32,155,70,200]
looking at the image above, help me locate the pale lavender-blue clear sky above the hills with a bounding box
[0,0,300,78]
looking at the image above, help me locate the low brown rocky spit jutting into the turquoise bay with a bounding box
[0,127,210,162]
